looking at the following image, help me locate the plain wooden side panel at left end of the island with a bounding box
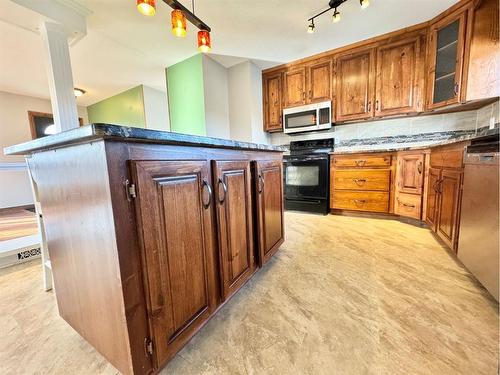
[27,140,133,374]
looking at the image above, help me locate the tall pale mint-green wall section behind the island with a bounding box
[167,54,206,135]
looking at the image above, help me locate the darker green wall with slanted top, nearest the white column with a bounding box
[87,85,146,128]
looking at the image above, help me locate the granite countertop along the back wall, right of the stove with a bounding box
[330,127,500,155]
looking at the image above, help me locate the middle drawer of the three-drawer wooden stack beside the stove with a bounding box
[332,169,391,191]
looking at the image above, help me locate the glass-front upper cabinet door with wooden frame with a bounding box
[427,10,467,109]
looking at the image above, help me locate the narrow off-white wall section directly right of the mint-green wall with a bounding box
[203,55,231,139]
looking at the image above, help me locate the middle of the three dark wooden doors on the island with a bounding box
[213,161,255,299]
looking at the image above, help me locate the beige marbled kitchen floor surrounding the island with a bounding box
[0,212,499,375]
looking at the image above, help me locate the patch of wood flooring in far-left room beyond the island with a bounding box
[0,209,38,241]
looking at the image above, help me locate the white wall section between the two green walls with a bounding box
[142,85,170,131]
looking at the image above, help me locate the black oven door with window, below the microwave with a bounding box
[283,155,328,200]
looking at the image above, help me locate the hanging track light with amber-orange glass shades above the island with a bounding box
[137,0,212,52]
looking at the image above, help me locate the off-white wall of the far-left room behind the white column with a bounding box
[0,91,88,208]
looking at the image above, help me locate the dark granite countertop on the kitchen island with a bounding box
[4,124,285,155]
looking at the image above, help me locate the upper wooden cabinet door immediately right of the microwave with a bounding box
[335,49,375,121]
